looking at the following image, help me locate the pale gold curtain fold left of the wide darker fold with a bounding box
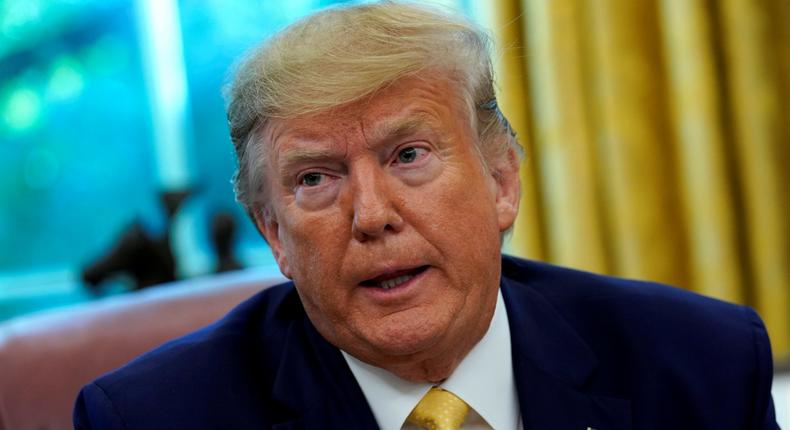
[524,1,608,271]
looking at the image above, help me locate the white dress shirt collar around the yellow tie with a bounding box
[341,291,521,430]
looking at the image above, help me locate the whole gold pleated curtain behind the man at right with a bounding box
[482,0,790,358]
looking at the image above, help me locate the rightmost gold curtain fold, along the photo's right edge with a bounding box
[719,0,790,360]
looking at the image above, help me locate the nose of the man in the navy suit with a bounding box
[351,166,403,242]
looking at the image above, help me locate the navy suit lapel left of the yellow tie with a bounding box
[272,316,377,429]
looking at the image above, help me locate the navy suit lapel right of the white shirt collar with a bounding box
[502,276,631,430]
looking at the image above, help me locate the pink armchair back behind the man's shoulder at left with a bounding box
[0,269,284,430]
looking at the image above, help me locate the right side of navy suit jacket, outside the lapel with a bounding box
[502,257,775,428]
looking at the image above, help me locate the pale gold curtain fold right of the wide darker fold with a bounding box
[657,0,744,302]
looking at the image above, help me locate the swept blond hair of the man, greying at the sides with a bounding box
[226,1,521,215]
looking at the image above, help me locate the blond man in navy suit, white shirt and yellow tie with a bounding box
[75,2,776,429]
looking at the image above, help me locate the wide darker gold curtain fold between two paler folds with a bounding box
[583,0,688,285]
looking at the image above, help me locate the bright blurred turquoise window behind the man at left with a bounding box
[0,0,470,320]
